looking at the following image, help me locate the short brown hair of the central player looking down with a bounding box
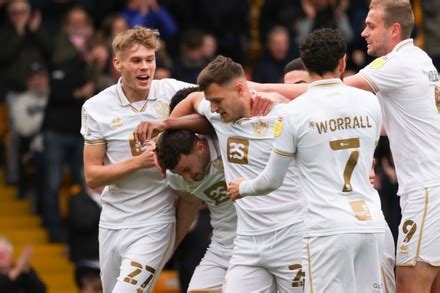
[197,55,244,91]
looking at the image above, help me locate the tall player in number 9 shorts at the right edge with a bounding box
[344,0,440,293]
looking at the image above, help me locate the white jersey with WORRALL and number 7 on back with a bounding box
[274,79,384,236]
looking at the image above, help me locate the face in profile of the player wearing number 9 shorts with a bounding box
[361,8,392,57]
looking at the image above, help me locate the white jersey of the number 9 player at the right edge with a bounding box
[360,39,440,194]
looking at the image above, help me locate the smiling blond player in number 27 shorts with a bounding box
[81,27,196,293]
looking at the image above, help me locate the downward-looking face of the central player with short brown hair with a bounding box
[205,83,246,122]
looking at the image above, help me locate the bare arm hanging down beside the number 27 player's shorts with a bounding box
[174,190,202,249]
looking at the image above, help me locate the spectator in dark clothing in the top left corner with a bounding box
[0,0,52,183]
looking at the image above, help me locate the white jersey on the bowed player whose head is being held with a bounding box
[167,137,237,254]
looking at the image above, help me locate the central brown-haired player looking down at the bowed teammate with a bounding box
[138,56,304,292]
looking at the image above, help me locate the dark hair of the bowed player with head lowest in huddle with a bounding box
[156,129,198,170]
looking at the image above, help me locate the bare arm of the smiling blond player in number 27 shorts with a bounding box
[84,144,156,188]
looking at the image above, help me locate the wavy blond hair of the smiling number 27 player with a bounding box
[112,26,160,55]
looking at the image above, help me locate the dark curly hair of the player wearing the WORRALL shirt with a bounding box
[299,28,347,76]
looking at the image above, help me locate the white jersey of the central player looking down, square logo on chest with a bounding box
[198,100,305,235]
